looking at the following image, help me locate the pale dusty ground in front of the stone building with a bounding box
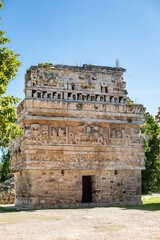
[0,205,160,240]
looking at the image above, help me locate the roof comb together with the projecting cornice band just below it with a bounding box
[15,64,145,124]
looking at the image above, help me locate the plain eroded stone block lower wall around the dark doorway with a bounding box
[15,170,141,207]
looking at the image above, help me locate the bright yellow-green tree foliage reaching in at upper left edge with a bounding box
[0,0,22,147]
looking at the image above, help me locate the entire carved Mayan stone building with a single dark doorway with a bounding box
[12,65,145,207]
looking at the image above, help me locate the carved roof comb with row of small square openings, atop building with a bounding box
[24,65,127,104]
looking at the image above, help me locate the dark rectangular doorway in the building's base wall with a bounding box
[82,176,92,203]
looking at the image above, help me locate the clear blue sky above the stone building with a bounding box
[1,0,160,115]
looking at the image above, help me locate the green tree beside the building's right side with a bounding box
[141,116,160,193]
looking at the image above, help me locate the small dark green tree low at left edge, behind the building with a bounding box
[0,148,12,182]
